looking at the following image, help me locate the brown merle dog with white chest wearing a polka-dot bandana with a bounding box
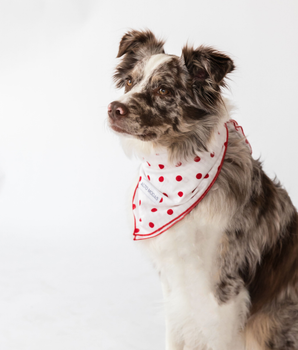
[108,30,298,350]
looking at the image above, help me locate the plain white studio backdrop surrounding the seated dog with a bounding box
[0,0,298,350]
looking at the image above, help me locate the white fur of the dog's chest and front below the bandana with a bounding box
[139,200,247,350]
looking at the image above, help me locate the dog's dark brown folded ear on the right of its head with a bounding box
[182,46,235,85]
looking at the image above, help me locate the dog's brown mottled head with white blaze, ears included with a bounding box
[108,30,234,157]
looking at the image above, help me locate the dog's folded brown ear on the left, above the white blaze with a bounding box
[117,30,164,57]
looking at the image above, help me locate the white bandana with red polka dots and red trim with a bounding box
[132,120,250,240]
